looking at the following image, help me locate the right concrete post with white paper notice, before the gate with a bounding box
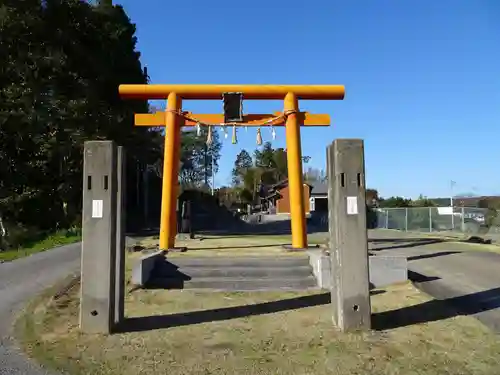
[327,139,371,332]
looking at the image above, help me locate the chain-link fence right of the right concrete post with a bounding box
[375,207,500,237]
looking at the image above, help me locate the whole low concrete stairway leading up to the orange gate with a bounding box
[148,256,317,291]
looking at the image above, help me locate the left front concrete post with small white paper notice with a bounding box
[80,141,117,333]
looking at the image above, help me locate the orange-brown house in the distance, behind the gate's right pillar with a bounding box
[262,180,328,214]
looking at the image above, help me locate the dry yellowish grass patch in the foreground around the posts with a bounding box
[17,284,500,375]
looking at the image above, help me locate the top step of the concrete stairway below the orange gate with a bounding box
[167,255,309,268]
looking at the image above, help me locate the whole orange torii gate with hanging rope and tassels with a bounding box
[119,85,345,250]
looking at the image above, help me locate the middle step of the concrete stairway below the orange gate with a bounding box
[172,265,313,279]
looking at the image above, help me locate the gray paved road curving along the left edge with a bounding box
[0,244,81,375]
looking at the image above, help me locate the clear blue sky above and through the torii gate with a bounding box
[117,0,500,197]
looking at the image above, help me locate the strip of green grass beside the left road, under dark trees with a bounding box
[0,230,82,261]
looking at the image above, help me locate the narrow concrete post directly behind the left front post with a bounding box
[114,146,127,325]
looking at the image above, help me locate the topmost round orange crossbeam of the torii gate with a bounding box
[118,85,345,100]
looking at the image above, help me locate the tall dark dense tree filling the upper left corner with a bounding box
[0,0,163,247]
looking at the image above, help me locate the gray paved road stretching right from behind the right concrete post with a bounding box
[369,230,500,333]
